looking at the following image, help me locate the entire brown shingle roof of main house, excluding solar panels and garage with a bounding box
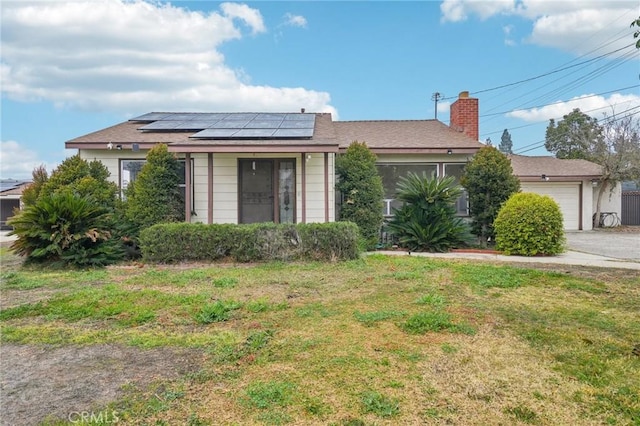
[65,113,484,154]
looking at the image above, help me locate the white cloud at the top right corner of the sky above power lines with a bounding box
[440,0,638,55]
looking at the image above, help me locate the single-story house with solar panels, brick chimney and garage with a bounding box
[65,92,620,230]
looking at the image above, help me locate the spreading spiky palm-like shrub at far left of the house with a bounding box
[9,191,124,267]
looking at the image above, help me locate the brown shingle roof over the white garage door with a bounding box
[509,154,602,180]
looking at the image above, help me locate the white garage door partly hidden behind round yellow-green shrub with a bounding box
[521,182,580,231]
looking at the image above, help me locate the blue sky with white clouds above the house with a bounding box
[0,0,640,179]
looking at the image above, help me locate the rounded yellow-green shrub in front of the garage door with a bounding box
[494,192,565,256]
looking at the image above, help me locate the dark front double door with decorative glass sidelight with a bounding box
[238,158,296,223]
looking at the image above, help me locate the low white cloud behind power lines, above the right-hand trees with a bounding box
[507,93,640,122]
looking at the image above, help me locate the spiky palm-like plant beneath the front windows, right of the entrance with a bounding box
[389,173,473,252]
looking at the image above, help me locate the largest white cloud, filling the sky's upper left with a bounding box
[0,0,335,113]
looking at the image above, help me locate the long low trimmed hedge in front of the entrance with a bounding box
[140,222,360,263]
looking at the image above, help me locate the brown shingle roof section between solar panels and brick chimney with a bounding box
[333,120,484,153]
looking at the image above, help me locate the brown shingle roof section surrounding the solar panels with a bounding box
[65,113,338,152]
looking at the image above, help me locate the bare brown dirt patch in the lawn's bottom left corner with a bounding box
[0,344,203,425]
